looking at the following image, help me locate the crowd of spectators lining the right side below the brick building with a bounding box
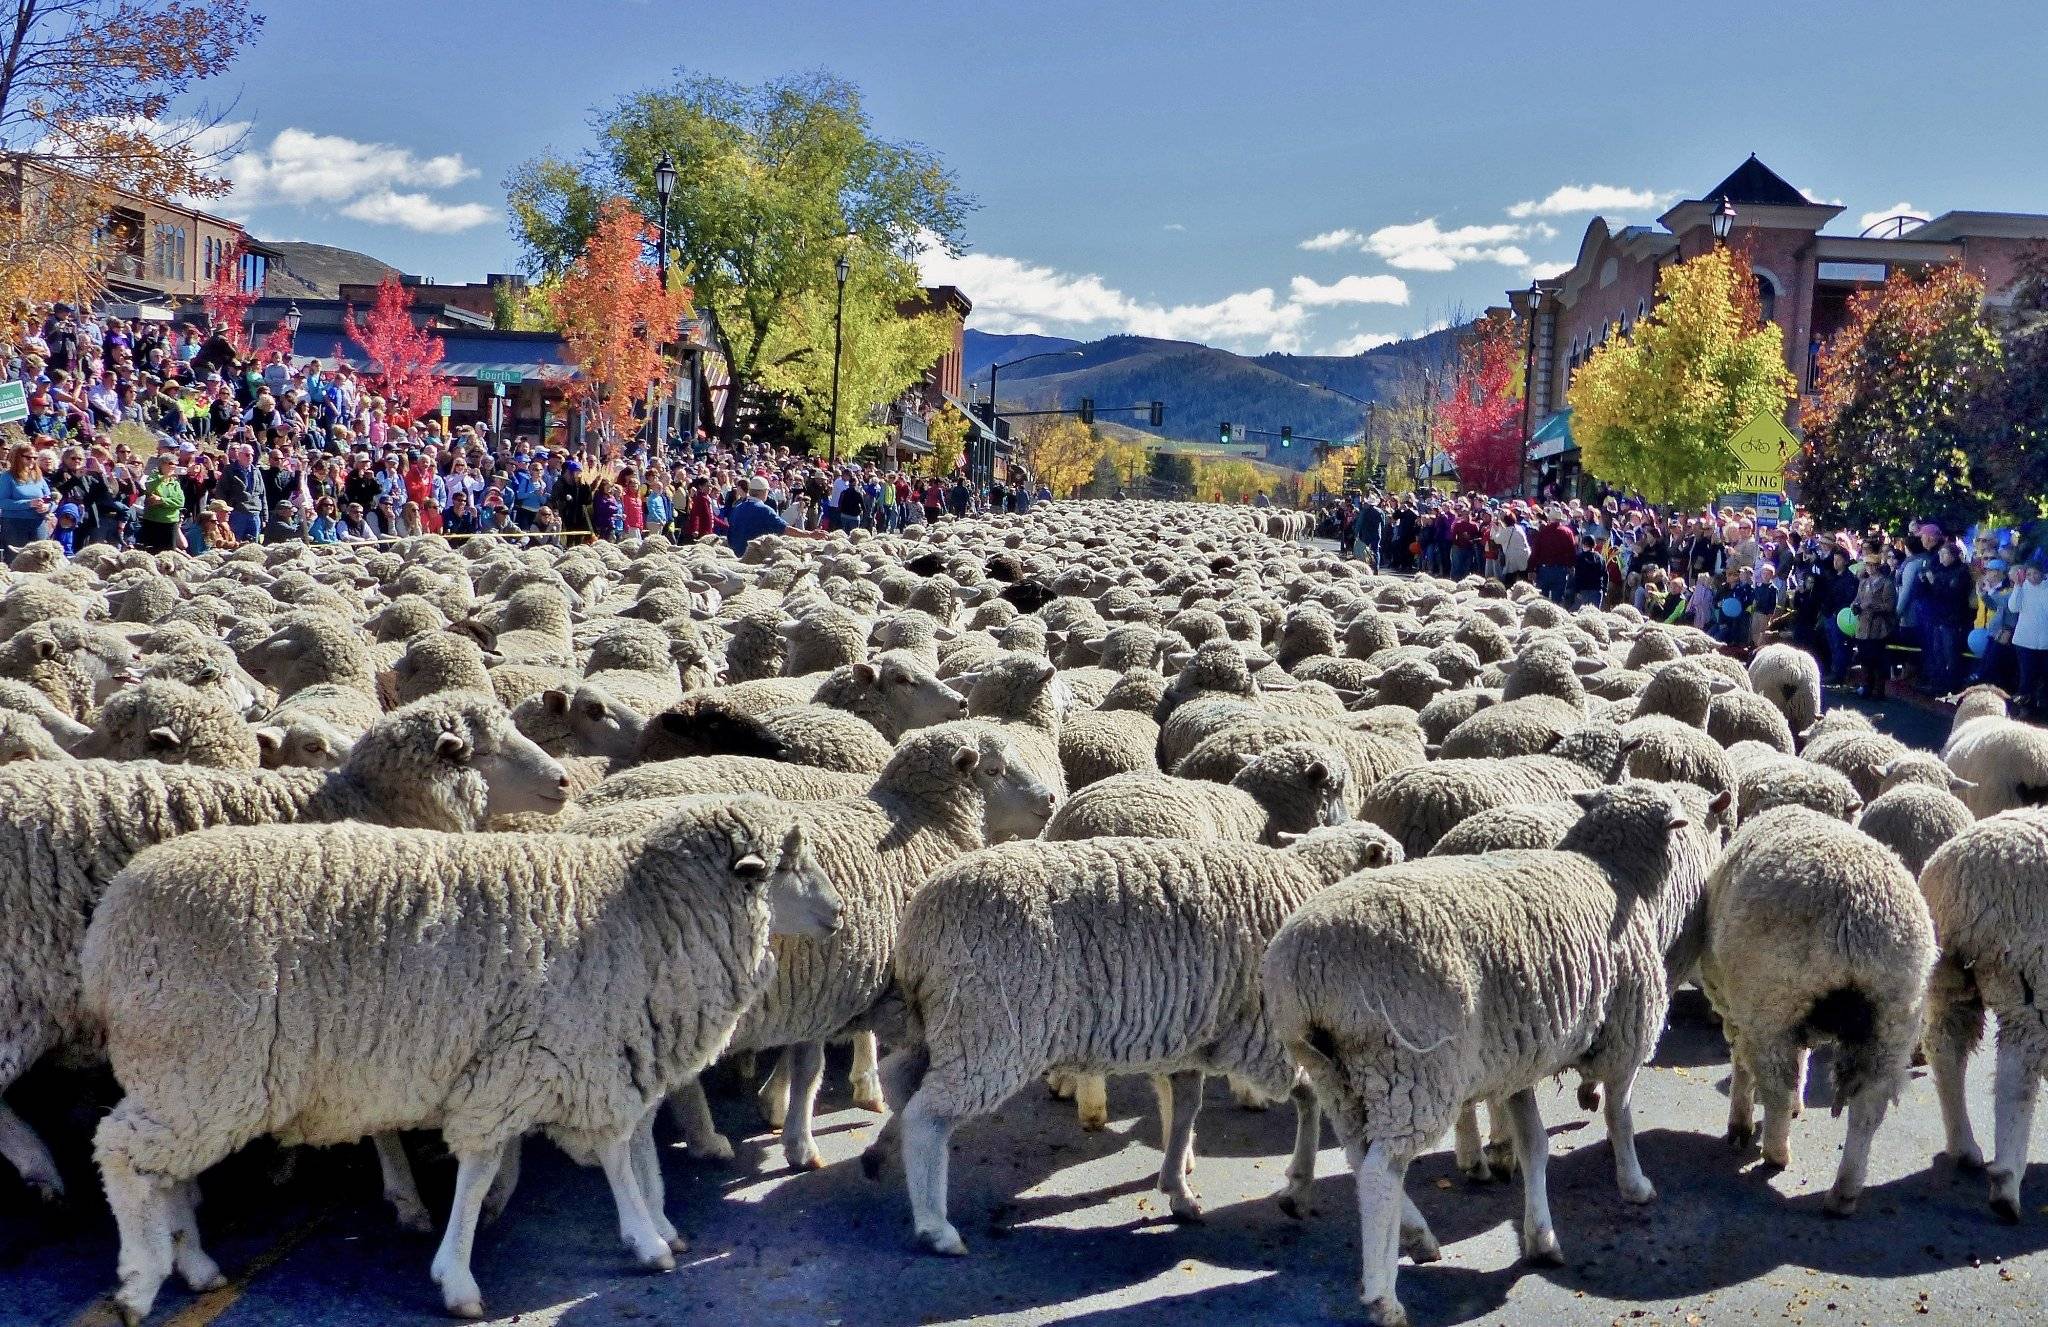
[1321,491,2048,715]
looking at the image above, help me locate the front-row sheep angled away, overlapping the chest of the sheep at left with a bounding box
[1262,782,1710,1325]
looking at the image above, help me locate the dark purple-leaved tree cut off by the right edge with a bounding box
[1972,244,2048,522]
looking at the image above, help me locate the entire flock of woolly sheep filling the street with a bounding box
[0,502,2048,1323]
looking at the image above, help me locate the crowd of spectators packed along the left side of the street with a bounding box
[0,303,1049,559]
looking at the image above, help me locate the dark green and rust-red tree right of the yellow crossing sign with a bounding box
[1794,264,2001,530]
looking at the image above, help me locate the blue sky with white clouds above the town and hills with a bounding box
[213,0,2048,352]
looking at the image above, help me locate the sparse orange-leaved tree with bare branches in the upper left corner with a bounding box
[0,0,262,299]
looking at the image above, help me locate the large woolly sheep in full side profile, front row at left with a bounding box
[84,799,840,1321]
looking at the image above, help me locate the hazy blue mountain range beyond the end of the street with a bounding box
[963,328,1458,463]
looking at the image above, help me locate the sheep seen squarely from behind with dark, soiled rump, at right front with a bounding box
[1700,807,1933,1216]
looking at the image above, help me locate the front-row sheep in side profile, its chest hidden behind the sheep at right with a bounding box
[862,825,1399,1255]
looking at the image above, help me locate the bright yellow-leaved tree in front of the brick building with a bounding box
[1569,246,1796,506]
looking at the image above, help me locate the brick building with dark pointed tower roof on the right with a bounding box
[1507,156,2048,489]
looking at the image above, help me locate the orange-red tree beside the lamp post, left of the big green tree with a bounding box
[553,199,690,442]
